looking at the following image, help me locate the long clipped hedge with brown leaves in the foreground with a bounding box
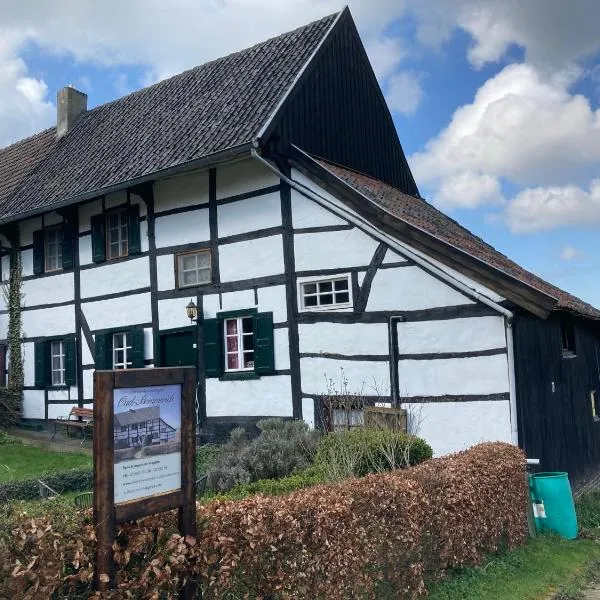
[0,443,527,600]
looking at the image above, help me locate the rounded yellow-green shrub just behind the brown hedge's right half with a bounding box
[315,428,433,481]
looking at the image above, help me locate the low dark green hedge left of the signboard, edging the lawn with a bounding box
[0,467,93,502]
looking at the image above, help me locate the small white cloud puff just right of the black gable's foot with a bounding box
[433,172,504,209]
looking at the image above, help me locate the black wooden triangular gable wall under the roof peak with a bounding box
[273,11,419,195]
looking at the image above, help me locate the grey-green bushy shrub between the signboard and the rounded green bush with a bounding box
[207,419,320,492]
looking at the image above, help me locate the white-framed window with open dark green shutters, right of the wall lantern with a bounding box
[203,309,275,379]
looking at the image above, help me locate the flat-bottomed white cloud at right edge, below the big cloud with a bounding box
[504,179,600,233]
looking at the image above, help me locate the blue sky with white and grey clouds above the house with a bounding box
[0,0,600,307]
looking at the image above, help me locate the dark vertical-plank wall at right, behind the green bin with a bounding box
[513,313,600,480]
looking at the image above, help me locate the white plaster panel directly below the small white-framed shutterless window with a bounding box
[298,323,389,355]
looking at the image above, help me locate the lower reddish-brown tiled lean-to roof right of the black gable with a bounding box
[317,159,600,319]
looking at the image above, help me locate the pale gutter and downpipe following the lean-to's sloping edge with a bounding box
[251,145,518,445]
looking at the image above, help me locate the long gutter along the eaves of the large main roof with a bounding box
[0,142,252,225]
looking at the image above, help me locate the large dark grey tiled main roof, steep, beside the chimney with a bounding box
[0,15,337,220]
